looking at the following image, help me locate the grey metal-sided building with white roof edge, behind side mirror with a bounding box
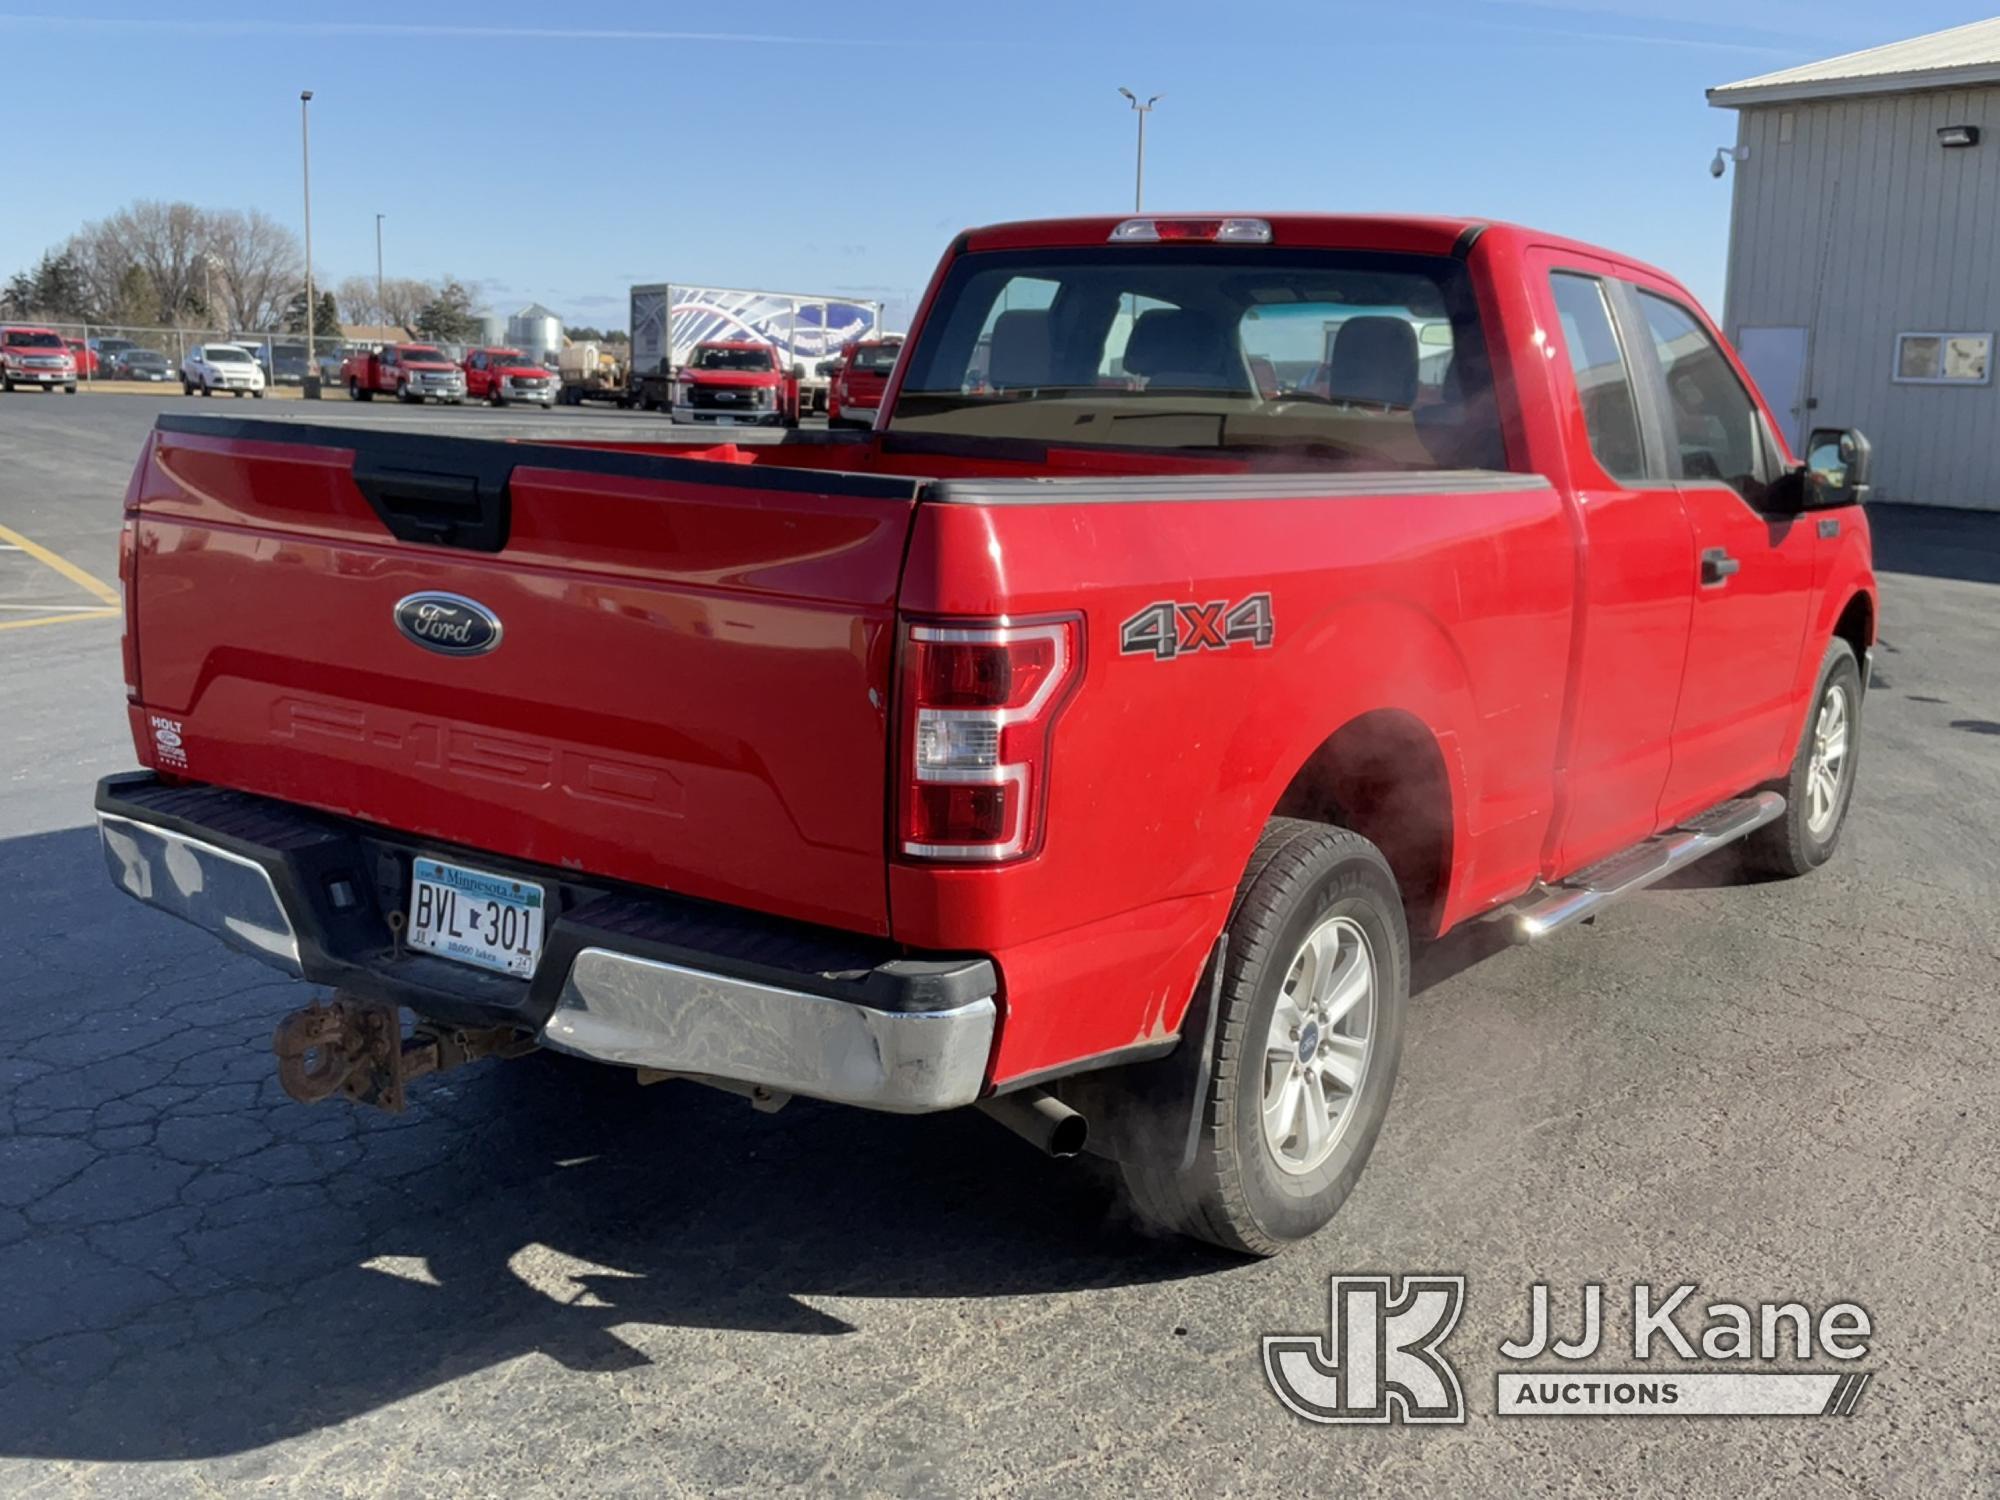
[1708,20,2000,510]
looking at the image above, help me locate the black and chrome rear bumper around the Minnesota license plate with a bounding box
[98,772,998,1112]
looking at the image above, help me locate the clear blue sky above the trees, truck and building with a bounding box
[0,0,1982,326]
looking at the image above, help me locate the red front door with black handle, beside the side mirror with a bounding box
[1626,286,1818,824]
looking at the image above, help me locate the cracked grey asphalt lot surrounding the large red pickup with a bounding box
[0,396,2000,1496]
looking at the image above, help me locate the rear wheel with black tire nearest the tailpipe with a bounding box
[1120,818,1410,1256]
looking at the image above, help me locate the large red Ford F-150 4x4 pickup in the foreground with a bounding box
[98,216,1876,1252]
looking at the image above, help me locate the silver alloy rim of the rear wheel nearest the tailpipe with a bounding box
[1262,916,1376,1176]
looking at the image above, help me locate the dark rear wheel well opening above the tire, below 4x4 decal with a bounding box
[1272,708,1452,936]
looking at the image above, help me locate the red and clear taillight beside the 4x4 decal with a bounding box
[898,616,1084,862]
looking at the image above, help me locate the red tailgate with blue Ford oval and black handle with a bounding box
[128,416,918,934]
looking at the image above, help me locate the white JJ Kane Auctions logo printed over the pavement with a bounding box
[1264,1276,1874,1424]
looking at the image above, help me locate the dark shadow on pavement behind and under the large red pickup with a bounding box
[0,828,1230,1460]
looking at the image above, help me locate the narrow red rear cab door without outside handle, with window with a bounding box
[1528,250,1694,872]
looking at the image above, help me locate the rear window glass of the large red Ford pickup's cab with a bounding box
[892,244,1506,468]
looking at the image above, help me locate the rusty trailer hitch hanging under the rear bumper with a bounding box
[270,992,536,1114]
